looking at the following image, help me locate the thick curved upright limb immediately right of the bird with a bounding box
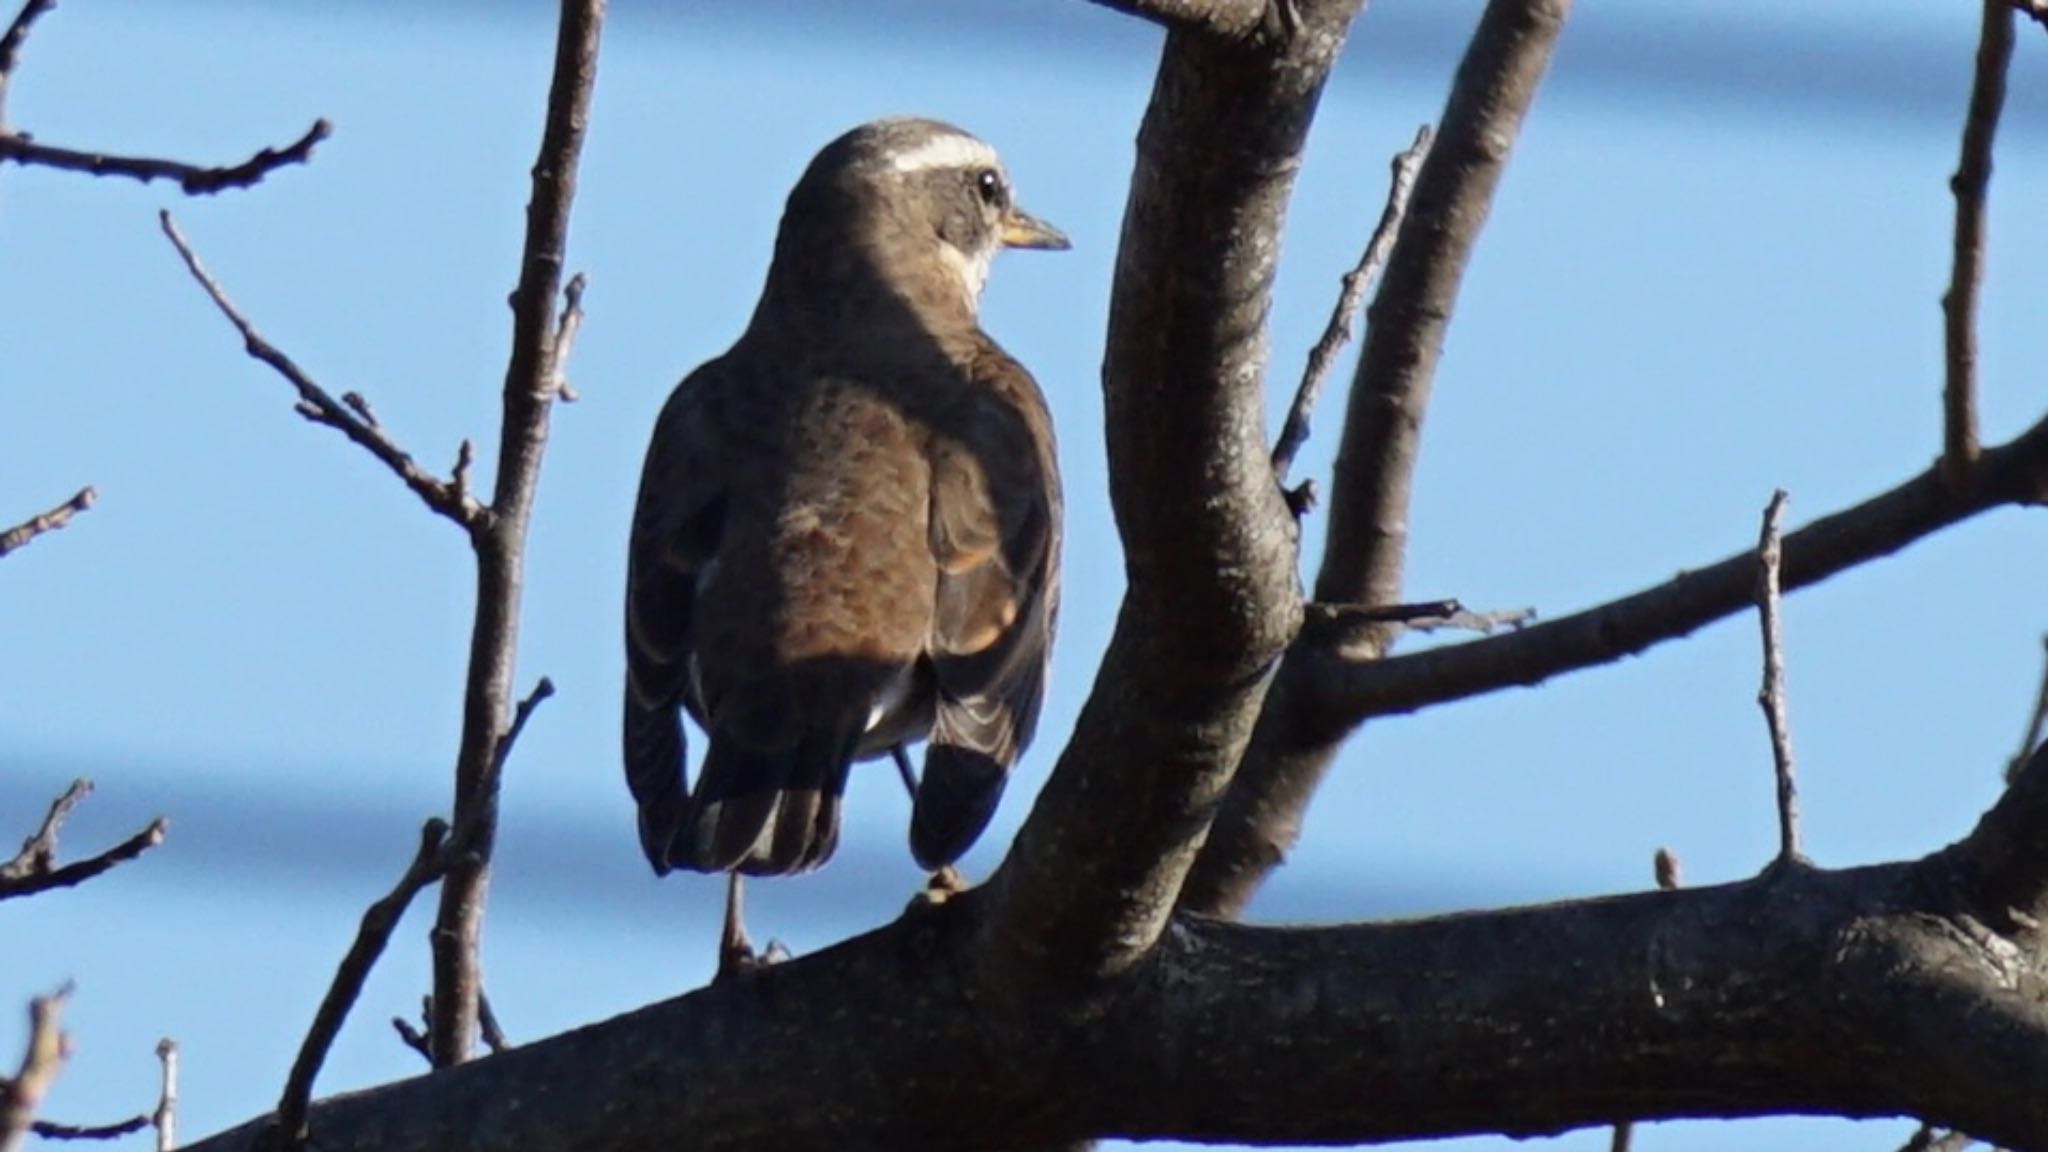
[987,0,1358,986]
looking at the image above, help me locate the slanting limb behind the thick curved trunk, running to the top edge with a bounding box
[1184,0,1571,914]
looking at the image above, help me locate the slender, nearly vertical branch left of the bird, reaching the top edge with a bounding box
[428,0,604,1066]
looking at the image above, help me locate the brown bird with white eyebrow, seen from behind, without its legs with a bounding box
[625,119,1067,873]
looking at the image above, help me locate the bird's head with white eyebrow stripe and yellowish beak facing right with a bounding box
[776,117,1069,314]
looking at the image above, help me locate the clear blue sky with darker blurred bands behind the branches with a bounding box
[0,0,2048,1150]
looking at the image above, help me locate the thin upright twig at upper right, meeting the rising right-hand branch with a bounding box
[1942,0,2013,486]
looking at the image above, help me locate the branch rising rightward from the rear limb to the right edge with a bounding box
[1315,407,2048,732]
